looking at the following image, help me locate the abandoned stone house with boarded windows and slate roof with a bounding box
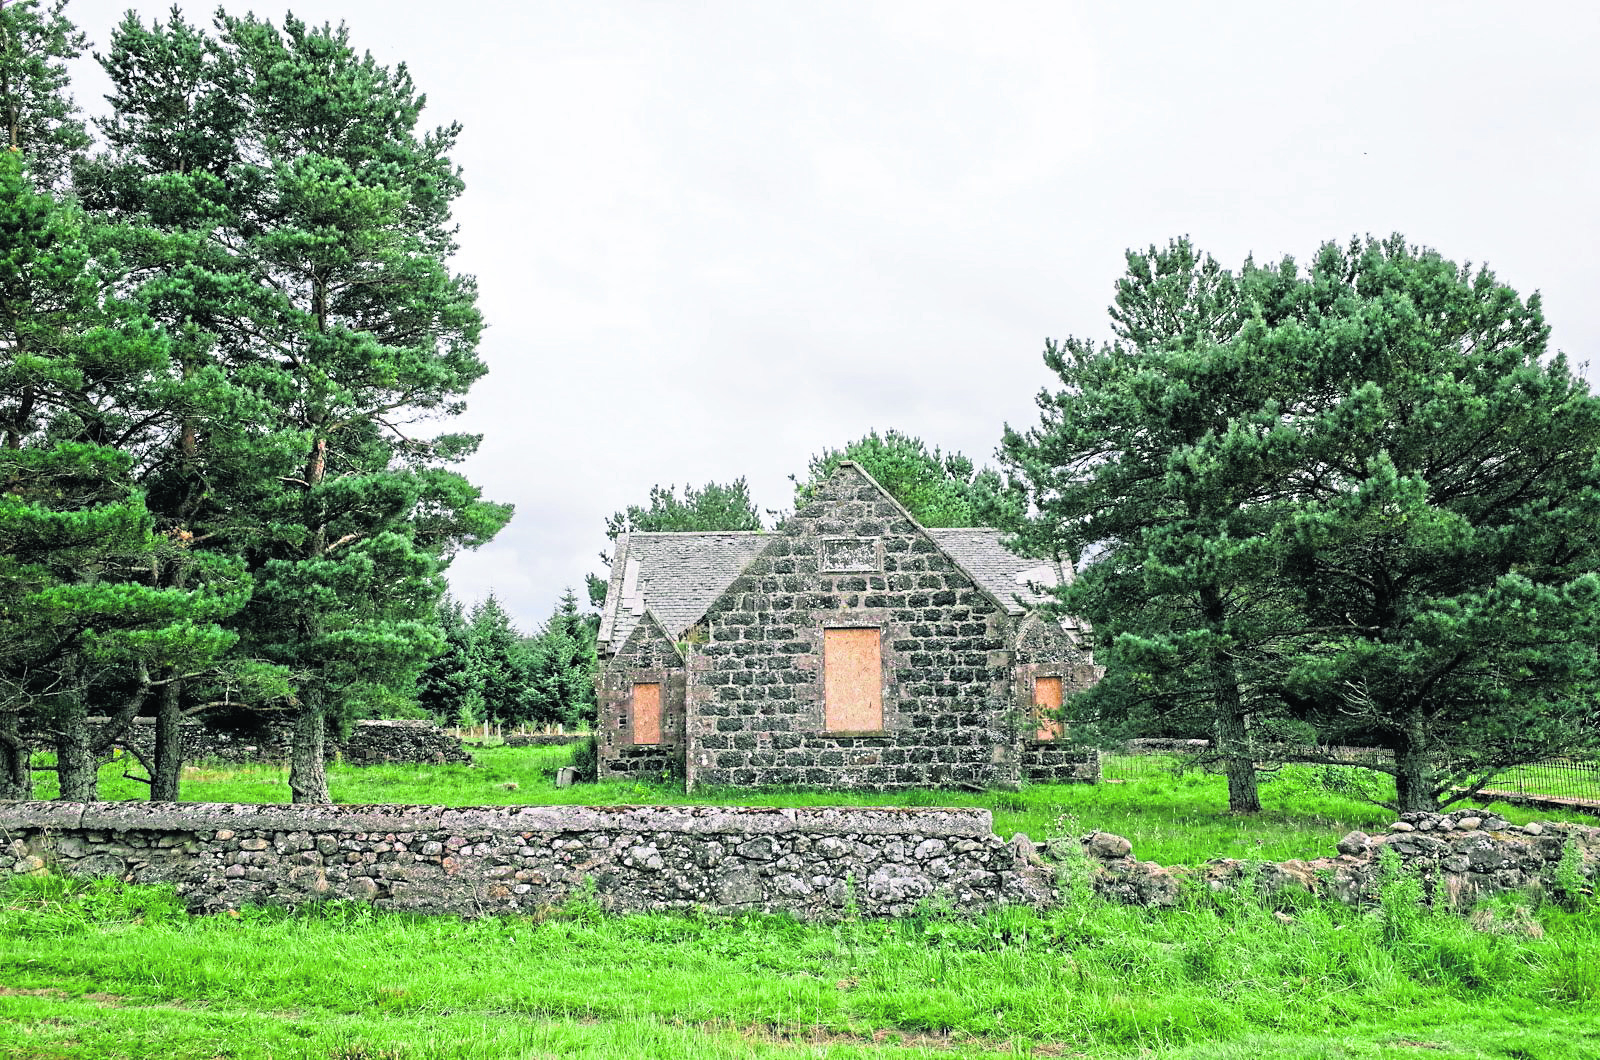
[598,463,1099,791]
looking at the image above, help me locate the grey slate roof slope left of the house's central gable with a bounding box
[600,530,773,652]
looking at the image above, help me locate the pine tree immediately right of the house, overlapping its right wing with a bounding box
[1002,240,1302,813]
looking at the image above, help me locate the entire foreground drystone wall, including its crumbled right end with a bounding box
[0,802,1600,919]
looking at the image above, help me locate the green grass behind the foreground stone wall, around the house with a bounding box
[35,746,1580,865]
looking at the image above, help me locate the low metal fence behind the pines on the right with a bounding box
[1101,740,1600,807]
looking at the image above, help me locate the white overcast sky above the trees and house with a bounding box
[67,0,1600,631]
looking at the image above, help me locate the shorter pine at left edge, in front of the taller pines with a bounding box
[0,152,248,799]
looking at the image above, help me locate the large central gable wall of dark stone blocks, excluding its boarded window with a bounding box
[686,468,1021,791]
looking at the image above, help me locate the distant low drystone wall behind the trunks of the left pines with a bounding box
[90,717,472,765]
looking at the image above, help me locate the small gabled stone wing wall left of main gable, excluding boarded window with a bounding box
[595,615,688,778]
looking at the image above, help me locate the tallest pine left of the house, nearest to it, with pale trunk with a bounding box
[85,16,509,801]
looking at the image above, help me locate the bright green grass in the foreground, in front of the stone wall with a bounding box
[0,877,1600,1060]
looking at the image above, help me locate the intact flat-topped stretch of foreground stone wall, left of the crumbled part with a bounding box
[0,802,1051,917]
